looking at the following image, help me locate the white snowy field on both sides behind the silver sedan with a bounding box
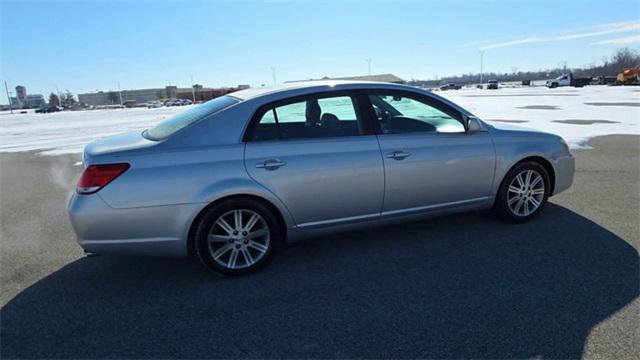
[0,86,640,155]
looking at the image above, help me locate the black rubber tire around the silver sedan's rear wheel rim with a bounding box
[195,198,284,276]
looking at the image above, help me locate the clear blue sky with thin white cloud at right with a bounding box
[1,0,640,97]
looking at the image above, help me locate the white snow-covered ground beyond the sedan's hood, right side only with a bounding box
[438,86,640,148]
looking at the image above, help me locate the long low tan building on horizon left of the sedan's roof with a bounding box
[78,85,248,106]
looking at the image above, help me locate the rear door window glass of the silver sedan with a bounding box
[252,96,361,140]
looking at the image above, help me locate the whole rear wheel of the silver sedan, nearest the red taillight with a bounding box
[195,199,282,275]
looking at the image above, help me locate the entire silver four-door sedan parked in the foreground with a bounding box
[68,81,574,275]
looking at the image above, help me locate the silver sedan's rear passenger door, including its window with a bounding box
[245,93,384,228]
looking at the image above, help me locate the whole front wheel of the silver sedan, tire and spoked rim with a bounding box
[495,161,550,222]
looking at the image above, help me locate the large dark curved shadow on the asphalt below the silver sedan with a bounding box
[1,203,639,358]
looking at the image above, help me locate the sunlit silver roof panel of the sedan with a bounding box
[229,80,413,100]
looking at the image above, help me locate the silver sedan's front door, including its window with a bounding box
[368,91,495,215]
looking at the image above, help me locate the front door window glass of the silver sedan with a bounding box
[369,95,465,134]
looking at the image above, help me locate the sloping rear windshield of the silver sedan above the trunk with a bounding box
[142,96,240,141]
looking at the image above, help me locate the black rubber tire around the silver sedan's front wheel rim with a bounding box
[493,161,551,222]
